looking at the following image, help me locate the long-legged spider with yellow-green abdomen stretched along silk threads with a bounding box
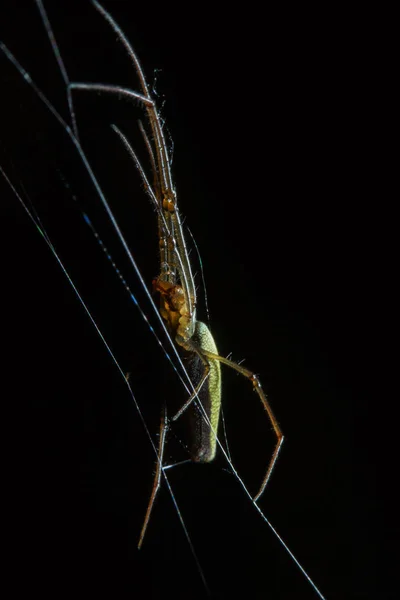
[63,0,284,548]
